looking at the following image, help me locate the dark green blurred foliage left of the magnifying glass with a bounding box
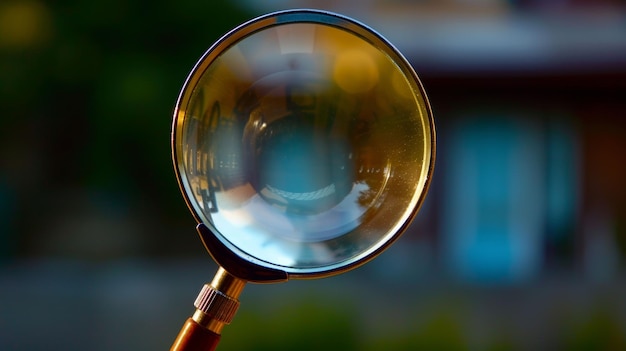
[0,0,252,254]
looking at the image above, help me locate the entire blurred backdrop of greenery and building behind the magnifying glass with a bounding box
[0,0,626,351]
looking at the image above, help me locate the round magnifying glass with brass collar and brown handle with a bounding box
[172,10,435,350]
